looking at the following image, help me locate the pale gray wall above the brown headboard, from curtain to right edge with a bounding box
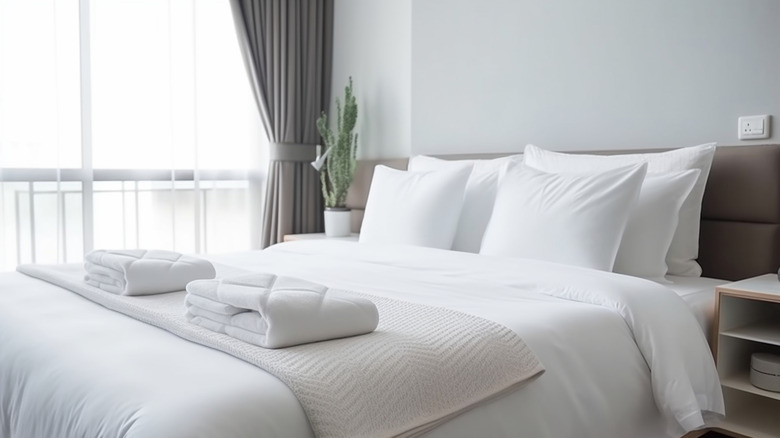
[334,0,780,157]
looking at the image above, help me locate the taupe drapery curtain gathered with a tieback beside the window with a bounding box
[230,0,333,248]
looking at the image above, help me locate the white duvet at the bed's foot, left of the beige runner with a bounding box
[0,273,311,438]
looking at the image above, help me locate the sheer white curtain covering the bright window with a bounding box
[0,0,267,270]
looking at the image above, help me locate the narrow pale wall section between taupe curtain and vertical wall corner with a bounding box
[331,0,412,158]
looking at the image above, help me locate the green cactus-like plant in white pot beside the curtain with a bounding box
[315,76,358,237]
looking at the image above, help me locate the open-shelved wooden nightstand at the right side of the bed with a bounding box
[712,274,780,438]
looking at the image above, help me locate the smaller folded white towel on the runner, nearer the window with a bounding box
[84,249,216,295]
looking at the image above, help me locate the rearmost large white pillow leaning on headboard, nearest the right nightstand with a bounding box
[525,143,715,277]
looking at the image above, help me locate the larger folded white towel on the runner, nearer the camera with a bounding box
[185,274,379,348]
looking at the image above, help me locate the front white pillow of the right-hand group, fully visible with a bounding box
[479,164,647,271]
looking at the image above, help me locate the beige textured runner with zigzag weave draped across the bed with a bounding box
[18,265,544,437]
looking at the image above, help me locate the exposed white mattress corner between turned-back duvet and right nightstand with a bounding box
[663,275,729,342]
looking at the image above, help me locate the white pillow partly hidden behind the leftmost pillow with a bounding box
[409,155,523,253]
